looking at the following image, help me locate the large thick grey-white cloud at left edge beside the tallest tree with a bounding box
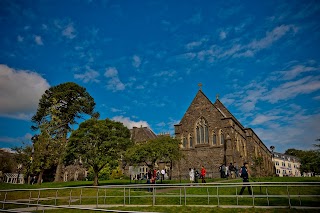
[0,64,50,120]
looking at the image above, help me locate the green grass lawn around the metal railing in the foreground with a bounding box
[0,177,320,213]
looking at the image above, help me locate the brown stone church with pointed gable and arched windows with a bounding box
[173,89,274,178]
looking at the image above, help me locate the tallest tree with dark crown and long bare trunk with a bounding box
[32,82,98,181]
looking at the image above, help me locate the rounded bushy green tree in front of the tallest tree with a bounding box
[65,118,132,185]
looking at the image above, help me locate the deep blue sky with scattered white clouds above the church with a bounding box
[0,0,320,152]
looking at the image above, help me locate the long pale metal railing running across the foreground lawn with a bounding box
[0,182,320,212]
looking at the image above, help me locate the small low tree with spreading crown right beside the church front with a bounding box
[125,136,182,179]
